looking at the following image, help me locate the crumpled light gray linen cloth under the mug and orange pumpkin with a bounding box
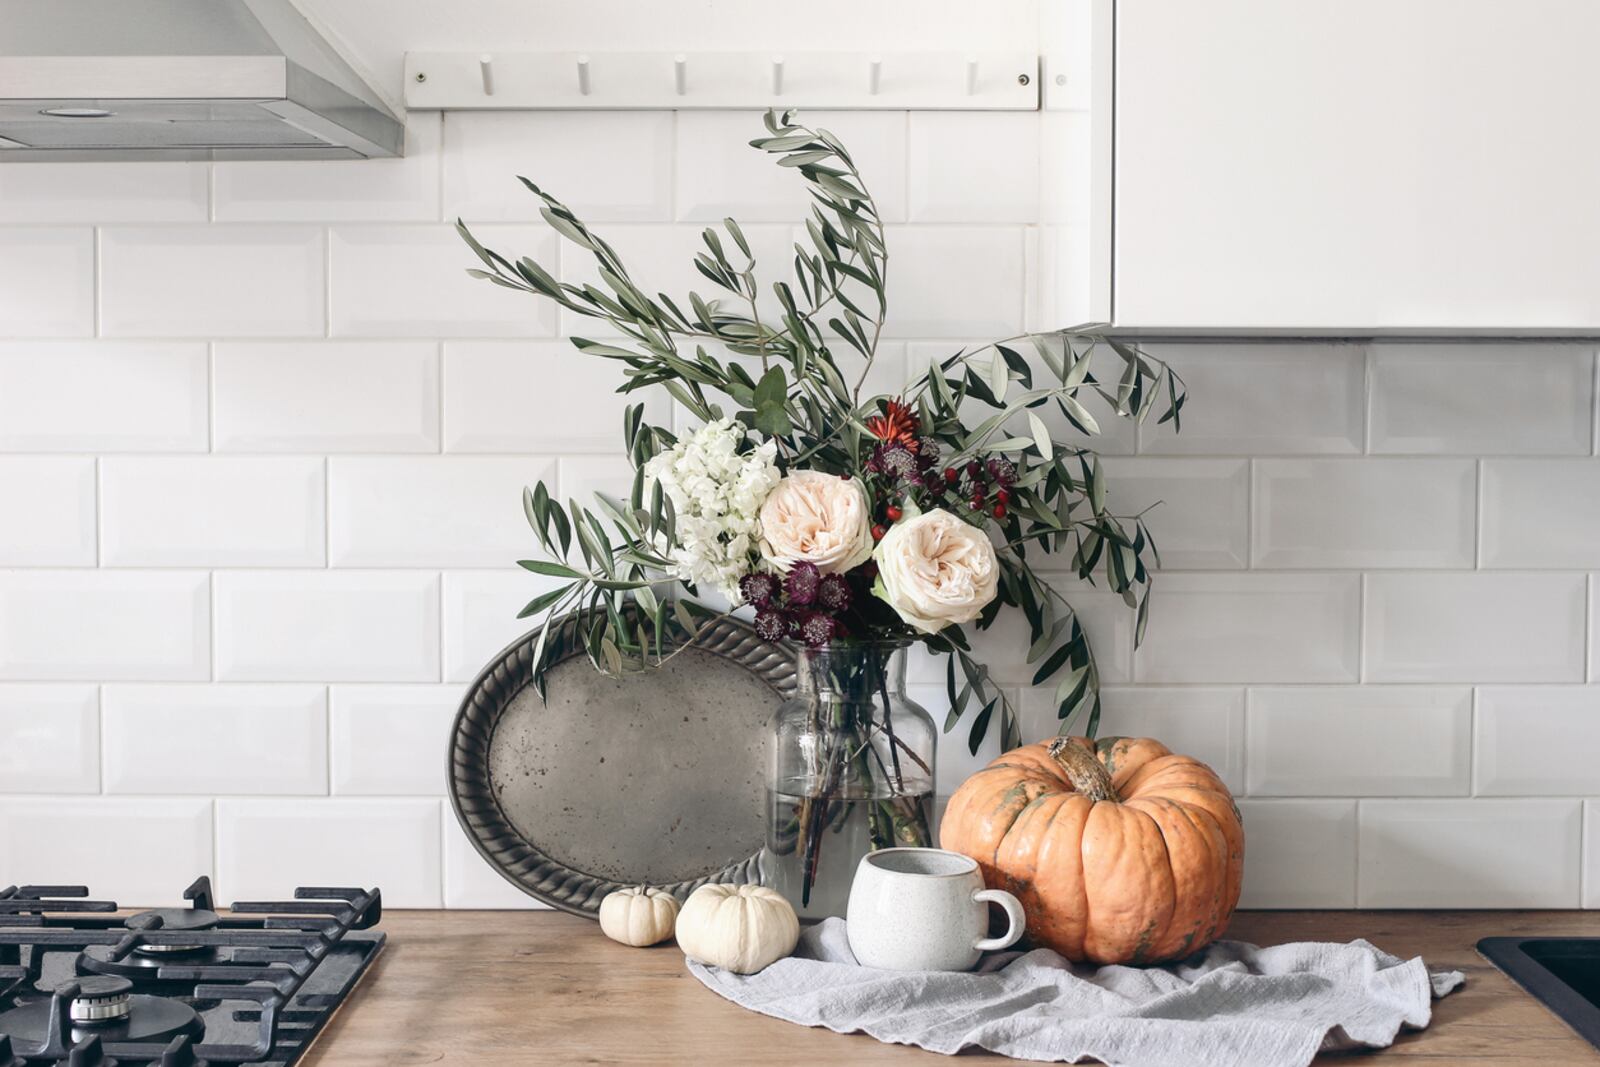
[688,918,1462,1067]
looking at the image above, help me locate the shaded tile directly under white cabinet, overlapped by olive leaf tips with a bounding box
[1139,344,1366,456]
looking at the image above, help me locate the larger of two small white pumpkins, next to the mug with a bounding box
[678,885,800,974]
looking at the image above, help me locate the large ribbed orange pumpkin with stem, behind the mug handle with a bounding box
[939,737,1245,963]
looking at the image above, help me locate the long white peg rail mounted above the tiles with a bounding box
[405,51,1038,110]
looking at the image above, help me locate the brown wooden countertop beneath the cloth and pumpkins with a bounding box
[302,912,1600,1067]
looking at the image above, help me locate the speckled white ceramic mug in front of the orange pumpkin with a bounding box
[845,848,1027,971]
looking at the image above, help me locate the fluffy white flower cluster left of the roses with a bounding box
[645,419,781,605]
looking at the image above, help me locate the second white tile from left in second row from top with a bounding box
[99,226,325,338]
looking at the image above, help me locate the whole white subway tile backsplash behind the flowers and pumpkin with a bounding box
[0,43,1600,907]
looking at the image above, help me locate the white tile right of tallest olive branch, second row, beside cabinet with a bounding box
[883,226,1026,341]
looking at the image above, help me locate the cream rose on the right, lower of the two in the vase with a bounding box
[872,509,1000,633]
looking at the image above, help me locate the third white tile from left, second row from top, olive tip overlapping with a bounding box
[328,226,555,338]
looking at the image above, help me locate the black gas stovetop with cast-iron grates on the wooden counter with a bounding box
[0,877,384,1067]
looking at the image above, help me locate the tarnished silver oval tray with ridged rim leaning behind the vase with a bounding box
[448,614,794,917]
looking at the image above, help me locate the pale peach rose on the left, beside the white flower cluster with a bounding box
[762,470,872,574]
